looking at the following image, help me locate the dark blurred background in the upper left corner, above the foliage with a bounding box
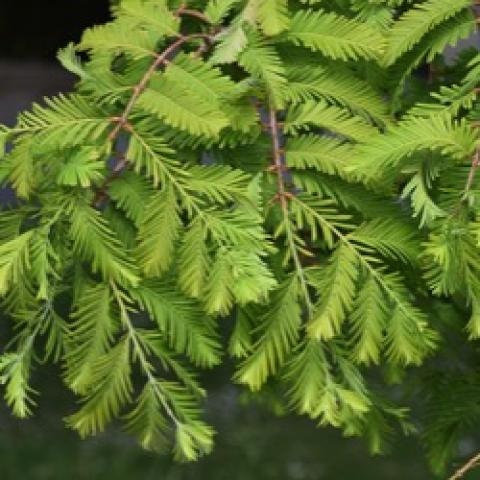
[0,0,110,125]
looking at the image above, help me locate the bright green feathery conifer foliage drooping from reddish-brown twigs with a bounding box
[0,0,480,473]
